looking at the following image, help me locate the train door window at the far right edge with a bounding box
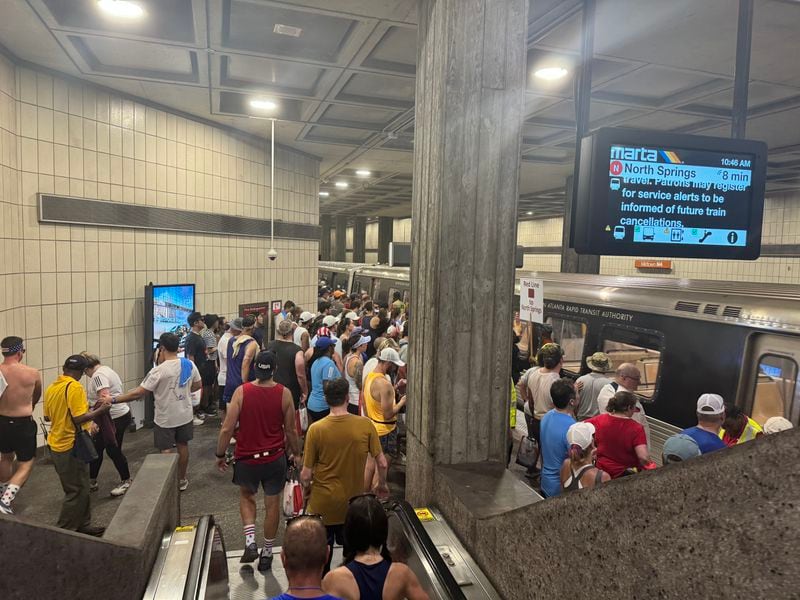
[750,354,800,425]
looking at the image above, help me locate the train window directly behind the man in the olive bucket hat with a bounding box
[602,327,661,399]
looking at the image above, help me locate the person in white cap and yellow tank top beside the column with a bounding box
[364,348,406,457]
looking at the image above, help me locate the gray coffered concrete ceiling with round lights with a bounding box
[0,0,800,223]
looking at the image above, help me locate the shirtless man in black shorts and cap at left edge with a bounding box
[0,336,42,515]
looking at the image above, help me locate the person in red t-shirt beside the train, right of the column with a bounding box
[586,392,654,479]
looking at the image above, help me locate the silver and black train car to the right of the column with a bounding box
[517,272,800,433]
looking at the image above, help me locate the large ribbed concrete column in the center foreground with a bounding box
[406,0,528,506]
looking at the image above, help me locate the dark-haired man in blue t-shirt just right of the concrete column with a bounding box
[539,378,575,497]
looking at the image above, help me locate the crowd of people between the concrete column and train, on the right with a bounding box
[515,342,792,497]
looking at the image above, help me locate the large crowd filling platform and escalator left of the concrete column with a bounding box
[0,288,416,598]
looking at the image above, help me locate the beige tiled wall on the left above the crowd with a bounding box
[0,58,319,432]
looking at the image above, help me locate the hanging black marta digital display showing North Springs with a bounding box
[573,129,767,259]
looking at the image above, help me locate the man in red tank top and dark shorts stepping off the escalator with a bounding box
[216,351,301,571]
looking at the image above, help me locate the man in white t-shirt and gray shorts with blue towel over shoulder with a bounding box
[115,333,203,491]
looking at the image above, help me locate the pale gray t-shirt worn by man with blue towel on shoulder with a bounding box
[142,359,200,428]
